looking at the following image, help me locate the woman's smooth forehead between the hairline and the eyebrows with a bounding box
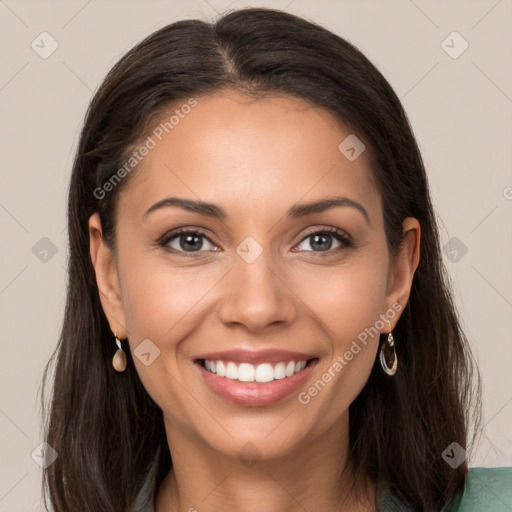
[122,92,380,222]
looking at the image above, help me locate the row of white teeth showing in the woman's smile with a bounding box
[204,359,306,383]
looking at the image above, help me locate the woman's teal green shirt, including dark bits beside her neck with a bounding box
[133,467,512,512]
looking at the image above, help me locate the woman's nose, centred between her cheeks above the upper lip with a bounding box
[219,250,298,332]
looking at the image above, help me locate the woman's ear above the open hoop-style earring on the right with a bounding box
[386,217,421,328]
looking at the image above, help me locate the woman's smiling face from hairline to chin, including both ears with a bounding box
[90,92,419,464]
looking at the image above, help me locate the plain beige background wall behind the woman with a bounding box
[0,0,512,512]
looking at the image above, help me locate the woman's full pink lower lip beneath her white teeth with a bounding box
[196,359,318,407]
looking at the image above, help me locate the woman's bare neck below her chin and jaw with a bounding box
[156,412,377,512]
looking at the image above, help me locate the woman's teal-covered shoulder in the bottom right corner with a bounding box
[446,467,512,512]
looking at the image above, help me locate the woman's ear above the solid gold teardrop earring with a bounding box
[89,213,127,339]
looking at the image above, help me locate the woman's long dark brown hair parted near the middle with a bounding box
[43,8,480,512]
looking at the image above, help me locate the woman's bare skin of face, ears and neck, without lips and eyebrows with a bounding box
[89,91,420,512]
